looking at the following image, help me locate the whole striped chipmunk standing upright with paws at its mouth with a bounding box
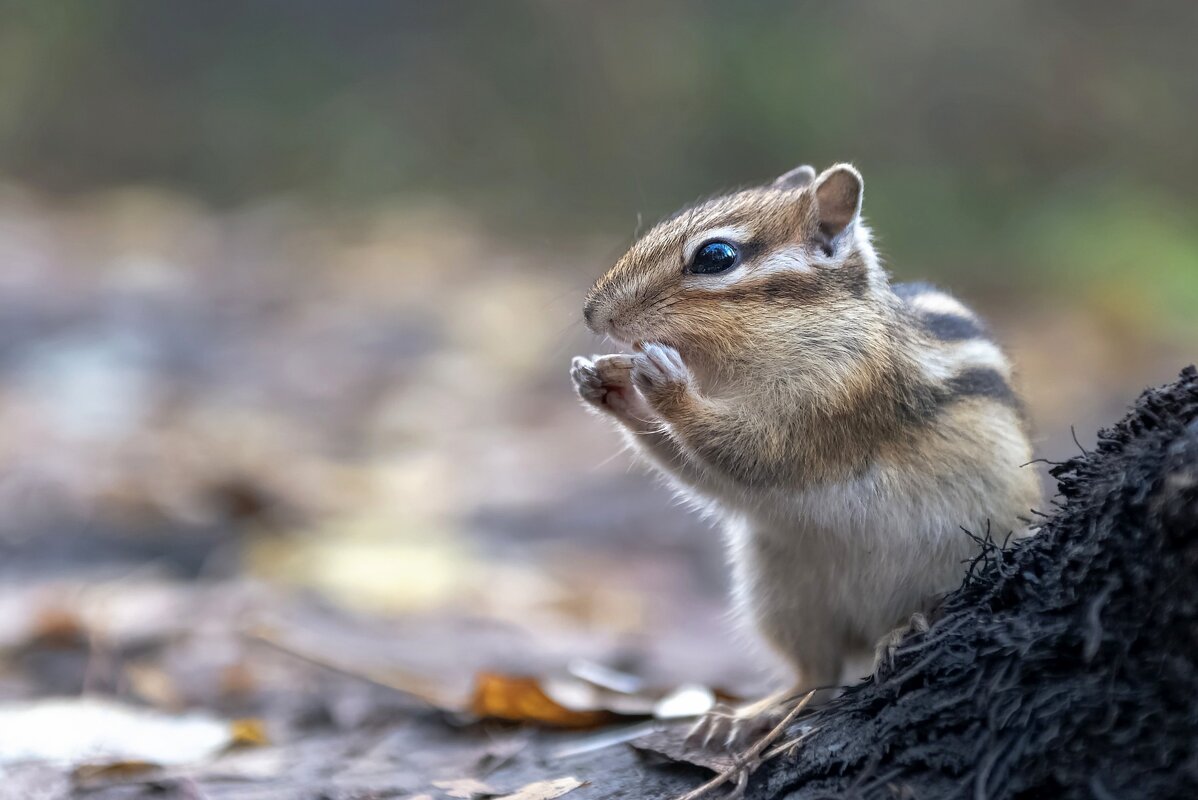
[571,164,1040,733]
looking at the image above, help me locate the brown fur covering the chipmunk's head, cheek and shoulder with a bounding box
[587,165,1030,485]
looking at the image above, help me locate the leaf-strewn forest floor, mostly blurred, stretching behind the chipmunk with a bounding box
[0,187,1196,798]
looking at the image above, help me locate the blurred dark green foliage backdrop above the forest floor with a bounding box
[0,0,1198,318]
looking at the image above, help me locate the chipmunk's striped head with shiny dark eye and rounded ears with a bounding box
[583,164,887,376]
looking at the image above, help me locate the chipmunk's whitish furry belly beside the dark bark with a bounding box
[725,471,1018,680]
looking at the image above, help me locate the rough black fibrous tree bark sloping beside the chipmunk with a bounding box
[749,366,1198,800]
